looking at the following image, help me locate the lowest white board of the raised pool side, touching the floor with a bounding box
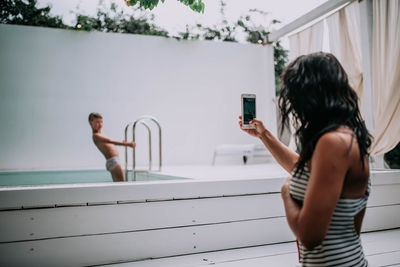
[0,218,294,266]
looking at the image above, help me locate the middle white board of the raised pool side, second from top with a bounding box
[0,194,284,242]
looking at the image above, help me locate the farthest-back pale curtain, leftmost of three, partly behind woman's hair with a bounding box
[289,21,324,150]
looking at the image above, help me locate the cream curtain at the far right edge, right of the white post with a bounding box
[372,0,400,155]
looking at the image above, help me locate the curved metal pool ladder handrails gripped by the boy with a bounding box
[125,116,162,181]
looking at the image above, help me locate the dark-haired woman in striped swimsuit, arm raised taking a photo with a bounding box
[239,52,372,266]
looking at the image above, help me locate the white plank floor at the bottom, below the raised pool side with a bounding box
[107,228,400,267]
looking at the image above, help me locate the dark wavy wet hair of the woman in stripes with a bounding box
[279,52,372,175]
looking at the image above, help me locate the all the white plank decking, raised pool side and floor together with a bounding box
[0,165,400,267]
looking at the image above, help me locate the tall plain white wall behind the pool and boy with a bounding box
[0,25,276,170]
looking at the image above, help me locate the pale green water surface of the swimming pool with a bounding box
[0,170,186,186]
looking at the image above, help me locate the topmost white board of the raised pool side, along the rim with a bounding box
[0,178,285,210]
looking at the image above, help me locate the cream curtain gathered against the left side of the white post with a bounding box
[326,1,363,100]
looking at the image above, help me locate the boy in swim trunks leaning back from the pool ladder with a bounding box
[89,112,136,182]
